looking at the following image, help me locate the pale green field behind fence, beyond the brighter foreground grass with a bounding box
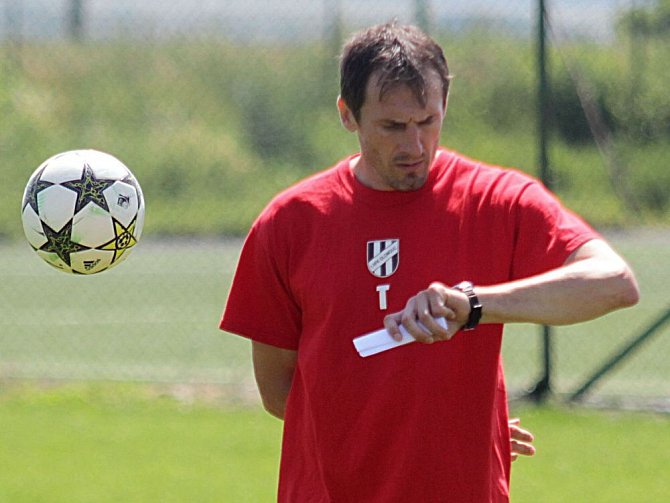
[0,230,670,397]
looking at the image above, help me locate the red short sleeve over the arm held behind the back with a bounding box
[219,217,301,349]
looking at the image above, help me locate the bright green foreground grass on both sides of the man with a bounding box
[0,384,670,503]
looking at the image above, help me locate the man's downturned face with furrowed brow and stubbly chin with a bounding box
[338,72,446,191]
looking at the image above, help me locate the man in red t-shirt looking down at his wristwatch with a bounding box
[221,23,638,503]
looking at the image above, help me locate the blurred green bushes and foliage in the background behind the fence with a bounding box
[0,2,670,238]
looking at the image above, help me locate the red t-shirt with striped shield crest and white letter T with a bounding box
[221,150,598,503]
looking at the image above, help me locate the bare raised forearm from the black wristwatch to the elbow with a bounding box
[476,244,639,325]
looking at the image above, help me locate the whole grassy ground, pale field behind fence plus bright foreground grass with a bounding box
[0,230,670,503]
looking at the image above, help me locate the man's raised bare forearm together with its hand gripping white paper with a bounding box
[384,239,639,343]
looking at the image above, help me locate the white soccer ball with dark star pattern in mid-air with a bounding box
[21,150,144,274]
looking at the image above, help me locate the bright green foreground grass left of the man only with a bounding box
[0,384,281,503]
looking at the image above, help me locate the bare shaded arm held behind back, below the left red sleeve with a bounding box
[251,341,298,419]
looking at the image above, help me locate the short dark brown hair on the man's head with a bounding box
[340,21,451,121]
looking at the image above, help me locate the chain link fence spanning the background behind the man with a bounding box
[0,0,670,408]
